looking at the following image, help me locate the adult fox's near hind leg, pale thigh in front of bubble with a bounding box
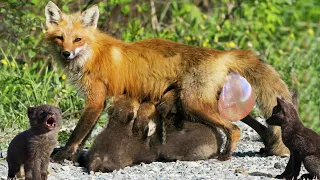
[180,59,240,160]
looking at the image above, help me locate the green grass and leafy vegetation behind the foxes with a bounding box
[0,0,320,147]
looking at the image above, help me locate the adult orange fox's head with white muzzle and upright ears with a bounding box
[45,1,99,65]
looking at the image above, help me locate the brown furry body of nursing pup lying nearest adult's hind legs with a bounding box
[156,122,222,161]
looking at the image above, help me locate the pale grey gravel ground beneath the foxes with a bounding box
[0,117,306,180]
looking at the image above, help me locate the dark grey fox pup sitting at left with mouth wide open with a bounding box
[7,105,62,180]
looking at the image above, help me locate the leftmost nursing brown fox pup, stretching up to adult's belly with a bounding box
[79,96,156,172]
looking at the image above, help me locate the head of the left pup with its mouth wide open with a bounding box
[28,104,62,133]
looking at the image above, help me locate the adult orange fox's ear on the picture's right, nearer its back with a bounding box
[81,5,99,28]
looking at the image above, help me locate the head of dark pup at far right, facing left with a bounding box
[267,98,299,126]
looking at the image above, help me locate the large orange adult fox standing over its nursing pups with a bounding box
[45,1,291,160]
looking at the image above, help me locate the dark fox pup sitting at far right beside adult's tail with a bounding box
[267,98,320,179]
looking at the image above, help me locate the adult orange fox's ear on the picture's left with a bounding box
[45,1,62,27]
